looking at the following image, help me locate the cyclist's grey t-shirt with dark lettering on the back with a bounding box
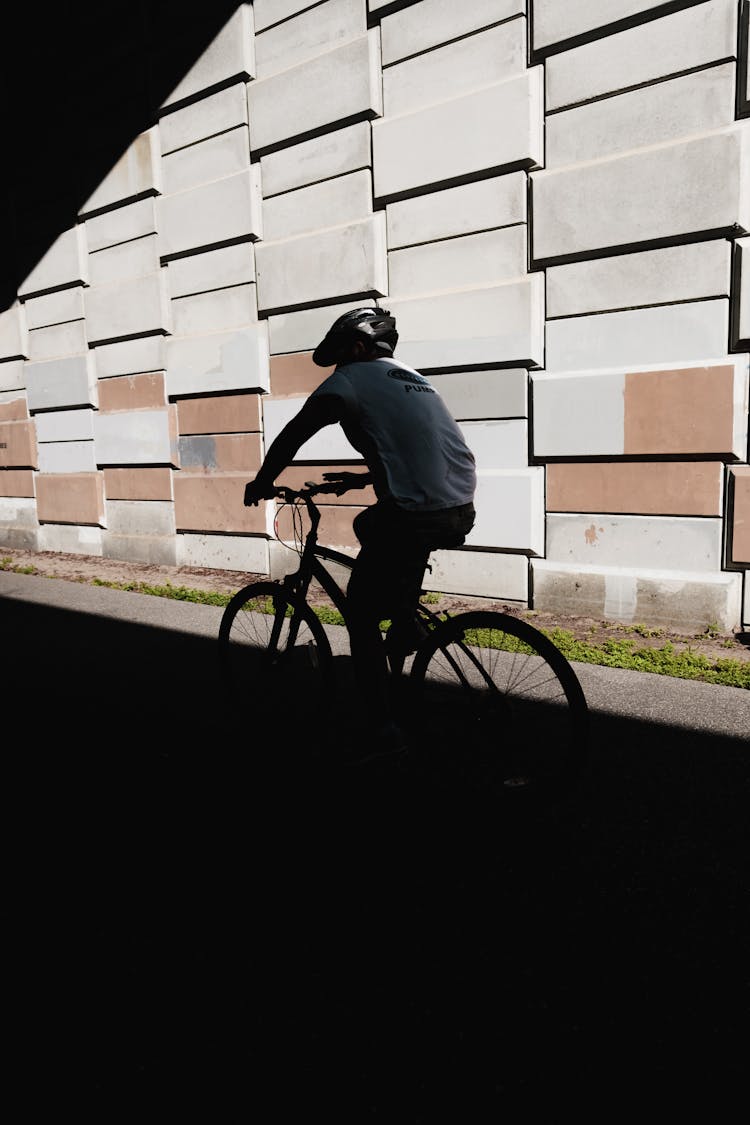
[313,357,477,512]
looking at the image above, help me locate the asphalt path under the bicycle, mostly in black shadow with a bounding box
[0,574,750,1125]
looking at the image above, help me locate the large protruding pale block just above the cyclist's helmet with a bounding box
[255,213,388,309]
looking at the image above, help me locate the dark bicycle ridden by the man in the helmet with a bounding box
[218,474,588,789]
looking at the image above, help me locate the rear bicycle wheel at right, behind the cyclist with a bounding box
[409,610,588,791]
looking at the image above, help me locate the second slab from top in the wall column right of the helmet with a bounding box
[382,18,526,117]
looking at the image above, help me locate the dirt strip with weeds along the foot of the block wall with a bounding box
[0,547,750,662]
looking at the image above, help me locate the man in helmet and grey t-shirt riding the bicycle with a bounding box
[244,307,476,749]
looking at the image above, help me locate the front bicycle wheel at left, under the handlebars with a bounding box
[218,582,333,707]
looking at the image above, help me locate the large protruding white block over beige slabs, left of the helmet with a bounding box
[165,322,270,397]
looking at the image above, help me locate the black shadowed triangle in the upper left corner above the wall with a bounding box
[0,0,244,309]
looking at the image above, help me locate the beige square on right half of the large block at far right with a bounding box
[623,365,735,456]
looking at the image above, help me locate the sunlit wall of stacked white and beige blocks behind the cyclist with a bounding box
[0,0,750,630]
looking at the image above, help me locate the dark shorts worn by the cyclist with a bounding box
[347,501,476,620]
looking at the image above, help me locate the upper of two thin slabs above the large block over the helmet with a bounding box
[260,122,372,198]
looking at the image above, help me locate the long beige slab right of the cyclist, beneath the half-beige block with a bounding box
[546,461,724,515]
